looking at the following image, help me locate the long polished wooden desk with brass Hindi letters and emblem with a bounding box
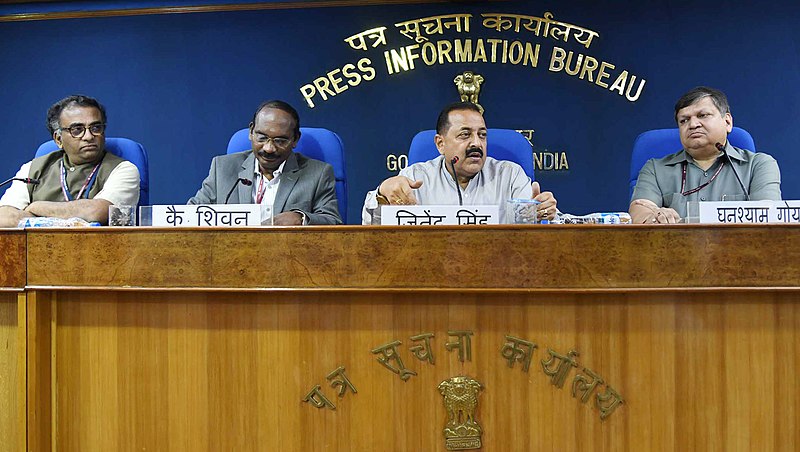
[9,225,800,451]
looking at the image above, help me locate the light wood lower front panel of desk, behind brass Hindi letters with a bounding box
[45,291,800,451]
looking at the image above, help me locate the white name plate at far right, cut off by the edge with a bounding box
[699,201,800,224]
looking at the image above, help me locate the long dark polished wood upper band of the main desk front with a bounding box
[28,225,800,291]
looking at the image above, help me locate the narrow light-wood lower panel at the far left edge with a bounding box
[0,292,18,451]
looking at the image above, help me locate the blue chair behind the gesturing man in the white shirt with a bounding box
[408,129,536,181]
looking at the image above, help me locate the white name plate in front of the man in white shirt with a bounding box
[381,205,500,226]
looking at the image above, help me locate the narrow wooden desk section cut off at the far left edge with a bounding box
[0,229,25,451]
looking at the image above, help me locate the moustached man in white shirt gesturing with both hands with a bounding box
[361,102,557,224]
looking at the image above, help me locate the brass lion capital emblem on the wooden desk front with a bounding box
[439,376,483,450]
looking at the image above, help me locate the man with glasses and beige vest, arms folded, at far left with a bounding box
[0,95,139,227]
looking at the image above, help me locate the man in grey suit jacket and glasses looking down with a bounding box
[188,100,342,226]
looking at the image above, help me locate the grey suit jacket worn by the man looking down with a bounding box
[188,151,342,224]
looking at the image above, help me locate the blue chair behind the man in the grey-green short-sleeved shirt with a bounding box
[630,127,756,196]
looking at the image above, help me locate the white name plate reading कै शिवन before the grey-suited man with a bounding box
[152,204,264,227]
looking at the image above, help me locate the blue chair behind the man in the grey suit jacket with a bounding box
[227,127,347,224]
